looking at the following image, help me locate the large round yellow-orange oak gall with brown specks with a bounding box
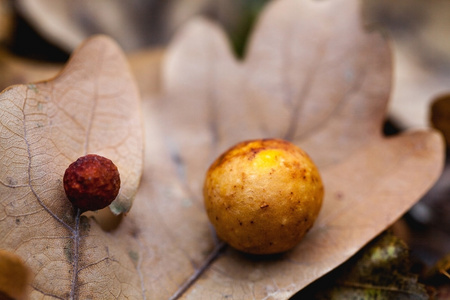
[203,139,324,254]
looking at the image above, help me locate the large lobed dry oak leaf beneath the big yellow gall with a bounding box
[134,0,444,299]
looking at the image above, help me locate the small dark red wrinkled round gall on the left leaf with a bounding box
[63,154,120,212]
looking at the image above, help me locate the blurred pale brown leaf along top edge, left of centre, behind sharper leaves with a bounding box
[16,0,212,51]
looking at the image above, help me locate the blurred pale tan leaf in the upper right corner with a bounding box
[362,0,450,128]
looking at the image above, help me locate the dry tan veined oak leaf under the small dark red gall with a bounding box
[0,36,143,299]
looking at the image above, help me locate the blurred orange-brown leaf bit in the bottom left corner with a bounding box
[0,249,31,300]
